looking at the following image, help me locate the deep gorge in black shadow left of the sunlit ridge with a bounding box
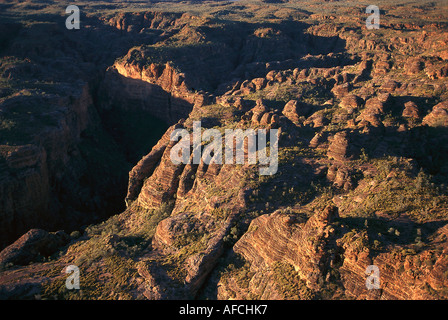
[2,72,172,248]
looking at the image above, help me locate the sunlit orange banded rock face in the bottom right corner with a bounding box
[339,228,448,300]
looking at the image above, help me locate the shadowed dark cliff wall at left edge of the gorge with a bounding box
[0,85,97,249]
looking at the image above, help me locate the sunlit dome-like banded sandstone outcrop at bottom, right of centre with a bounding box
[218,207,338,299]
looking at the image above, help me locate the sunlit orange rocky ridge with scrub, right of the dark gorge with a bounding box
[0,0,448,299]
